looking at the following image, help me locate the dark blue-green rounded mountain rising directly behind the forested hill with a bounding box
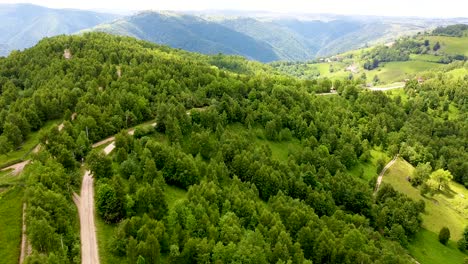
[83,11,281,61]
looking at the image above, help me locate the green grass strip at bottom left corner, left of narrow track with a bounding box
[0,187,23,263]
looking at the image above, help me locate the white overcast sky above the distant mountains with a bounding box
[0,0,468,17]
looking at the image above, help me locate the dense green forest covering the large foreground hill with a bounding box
[0,33,468,263]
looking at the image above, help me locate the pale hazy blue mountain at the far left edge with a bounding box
[0,4,118,56]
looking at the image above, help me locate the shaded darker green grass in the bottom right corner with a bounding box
[409,229,467,264]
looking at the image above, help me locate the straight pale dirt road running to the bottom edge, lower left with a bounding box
[73,171,99,264]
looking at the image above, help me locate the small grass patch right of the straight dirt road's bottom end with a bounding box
[96,216,126,264]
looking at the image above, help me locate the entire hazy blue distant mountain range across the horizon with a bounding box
[0,5,468,62]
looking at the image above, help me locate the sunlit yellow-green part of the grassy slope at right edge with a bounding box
[383,159,468,241]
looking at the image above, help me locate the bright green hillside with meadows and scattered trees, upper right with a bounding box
[271,26,468,83]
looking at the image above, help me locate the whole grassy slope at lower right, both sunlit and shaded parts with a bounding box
[383,159,468,264]
